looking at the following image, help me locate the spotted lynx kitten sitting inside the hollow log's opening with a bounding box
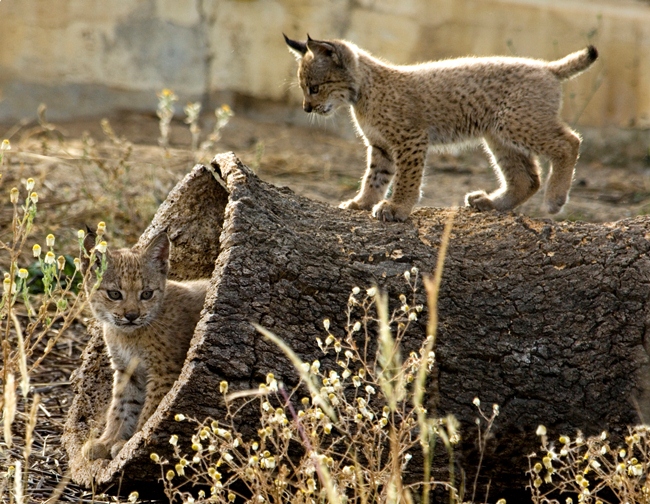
[83,233,208,460]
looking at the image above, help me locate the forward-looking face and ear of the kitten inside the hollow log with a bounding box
[90,235,169,332]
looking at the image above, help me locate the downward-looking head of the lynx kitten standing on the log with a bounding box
[285,36,358,115]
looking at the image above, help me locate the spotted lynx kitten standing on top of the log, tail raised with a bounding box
[284,35,598,221]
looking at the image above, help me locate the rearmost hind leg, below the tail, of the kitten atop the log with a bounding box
[538,125,580,214]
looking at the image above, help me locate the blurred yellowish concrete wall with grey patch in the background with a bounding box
[0,0,650,129]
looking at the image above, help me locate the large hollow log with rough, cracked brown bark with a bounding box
[64,154,650,496]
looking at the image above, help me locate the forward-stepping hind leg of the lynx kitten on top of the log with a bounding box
[465,138,541,210]
